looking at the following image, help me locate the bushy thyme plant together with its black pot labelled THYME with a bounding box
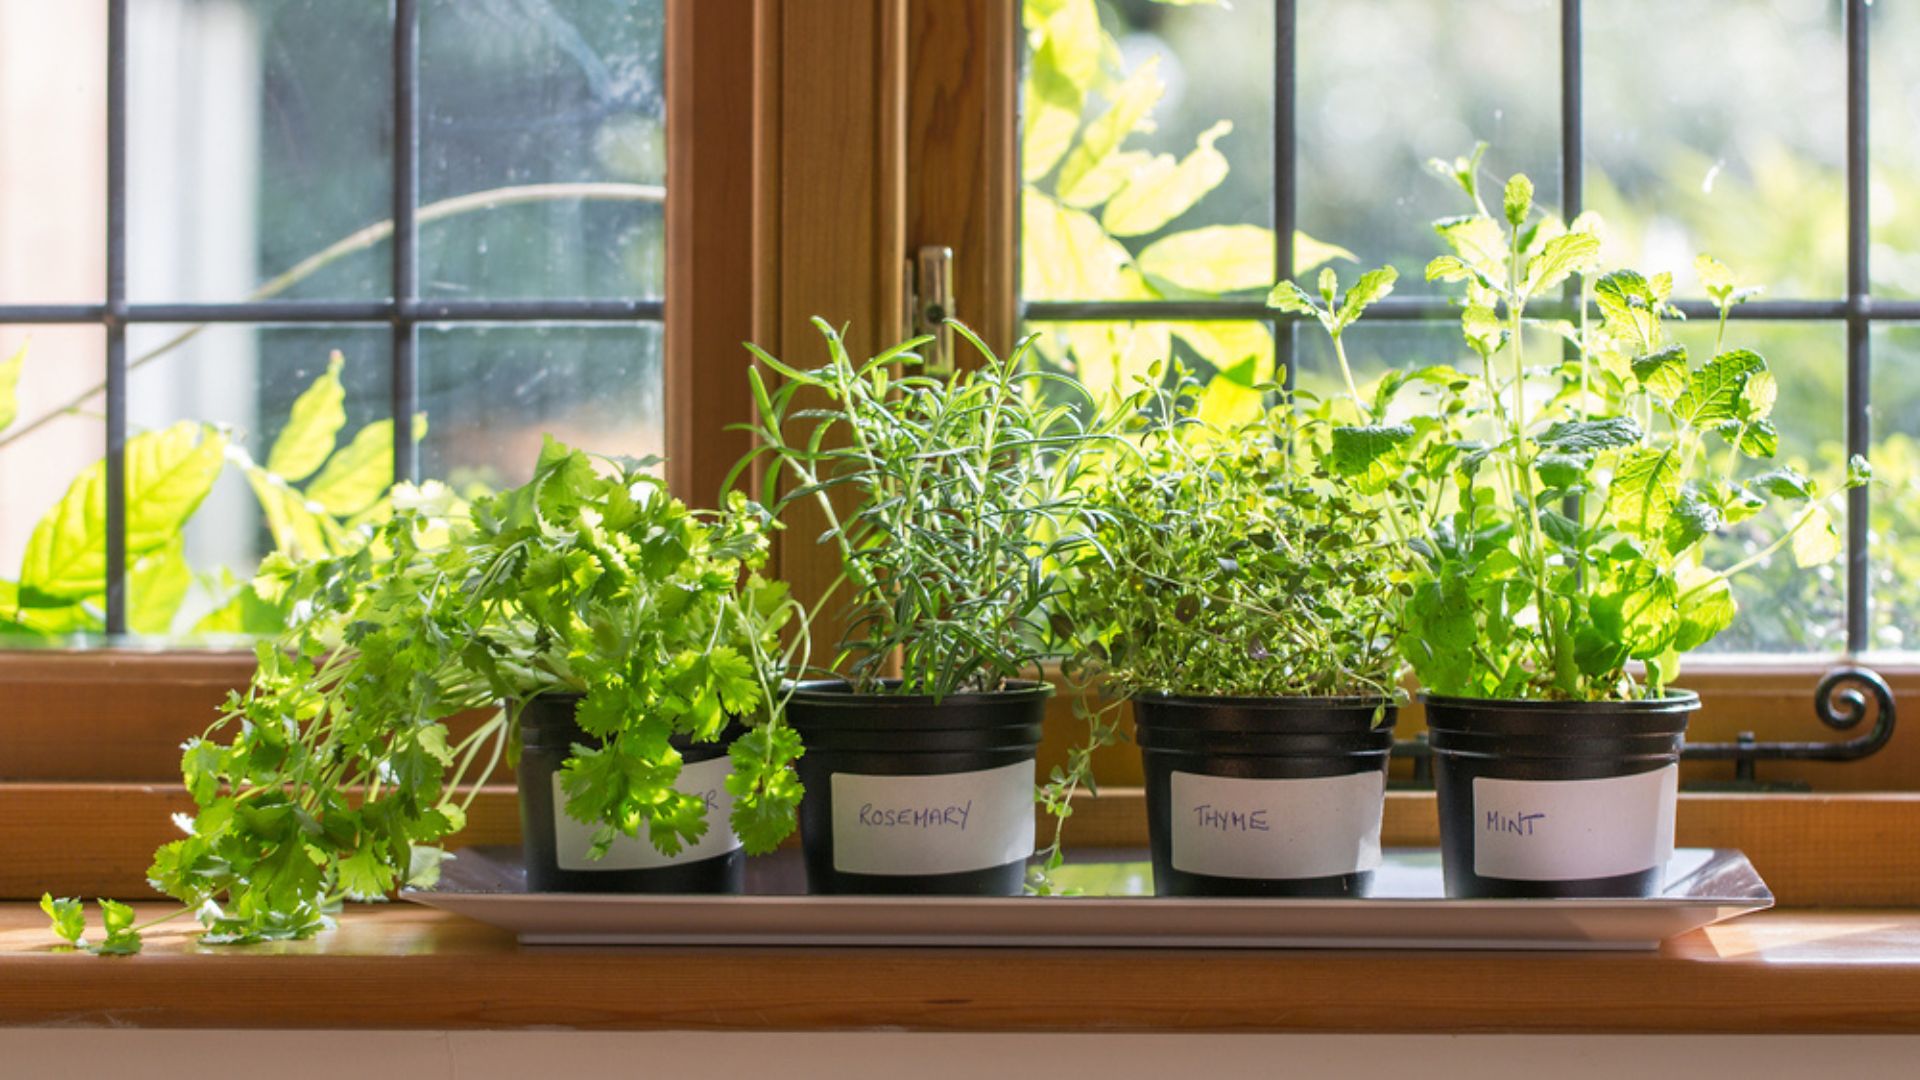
[1060,365,1400,896]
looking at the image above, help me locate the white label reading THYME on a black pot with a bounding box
[1171,769,1386,878]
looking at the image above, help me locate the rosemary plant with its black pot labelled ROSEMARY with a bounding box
[733,319,1092,894]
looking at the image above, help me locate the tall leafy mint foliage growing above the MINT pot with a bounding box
[1313,150,1866,701]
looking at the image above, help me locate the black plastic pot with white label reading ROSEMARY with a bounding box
[787,678,1052,896]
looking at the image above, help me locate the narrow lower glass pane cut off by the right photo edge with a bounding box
[1866,323,1920,653]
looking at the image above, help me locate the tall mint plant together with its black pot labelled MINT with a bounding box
[1313,150,1866,897]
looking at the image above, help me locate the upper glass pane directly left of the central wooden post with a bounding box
[420,0,664,298]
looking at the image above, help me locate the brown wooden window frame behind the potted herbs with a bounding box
[0,0,1920,903]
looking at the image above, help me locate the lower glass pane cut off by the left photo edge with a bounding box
[0,325,108,646]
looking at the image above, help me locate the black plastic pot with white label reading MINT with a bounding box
[1423,690,1699,897]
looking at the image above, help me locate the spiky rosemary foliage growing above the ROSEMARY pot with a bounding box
[730,319,1100,698]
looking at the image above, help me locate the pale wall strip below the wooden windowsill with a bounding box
[0,1028,1920,1080]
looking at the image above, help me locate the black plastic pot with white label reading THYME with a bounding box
[1133,694,1398,896]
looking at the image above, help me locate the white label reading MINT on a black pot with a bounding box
[1473,765,1680,882]
